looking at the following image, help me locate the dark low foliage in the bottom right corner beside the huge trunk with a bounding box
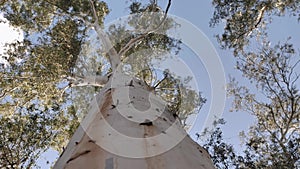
[203,119,299,169]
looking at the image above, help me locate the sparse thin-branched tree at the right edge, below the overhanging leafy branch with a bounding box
[229,40,300,168]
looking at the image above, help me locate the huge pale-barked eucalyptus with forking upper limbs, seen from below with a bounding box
[54,0,214,169]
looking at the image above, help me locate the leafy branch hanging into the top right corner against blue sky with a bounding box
[210,0,300,55]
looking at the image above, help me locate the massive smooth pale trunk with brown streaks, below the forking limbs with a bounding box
[54,75,214,169]
